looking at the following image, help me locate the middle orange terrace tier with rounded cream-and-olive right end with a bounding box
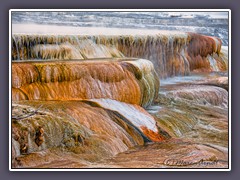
[12,59,159,107]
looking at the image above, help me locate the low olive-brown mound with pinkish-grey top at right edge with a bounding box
[155,81,228,141]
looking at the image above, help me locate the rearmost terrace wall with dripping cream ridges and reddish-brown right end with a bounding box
[12,31,227,78]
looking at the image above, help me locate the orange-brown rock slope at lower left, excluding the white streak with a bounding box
[12,101,153,162]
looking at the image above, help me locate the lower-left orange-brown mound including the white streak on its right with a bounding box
[12,99,167,166]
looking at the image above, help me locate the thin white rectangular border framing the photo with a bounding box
[9,9,232,171]
